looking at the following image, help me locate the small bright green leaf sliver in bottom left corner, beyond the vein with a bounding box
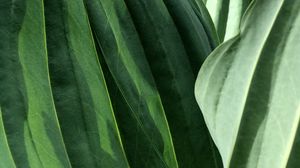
[0,108,16,168]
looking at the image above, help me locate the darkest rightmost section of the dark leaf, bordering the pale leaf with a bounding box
[126,0,219,168]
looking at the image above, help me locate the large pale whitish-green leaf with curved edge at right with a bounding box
[196,0,300,168]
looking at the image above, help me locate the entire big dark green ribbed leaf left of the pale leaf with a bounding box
[0,0,225,168]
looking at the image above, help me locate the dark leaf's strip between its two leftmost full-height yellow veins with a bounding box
[45,0,128,168]
